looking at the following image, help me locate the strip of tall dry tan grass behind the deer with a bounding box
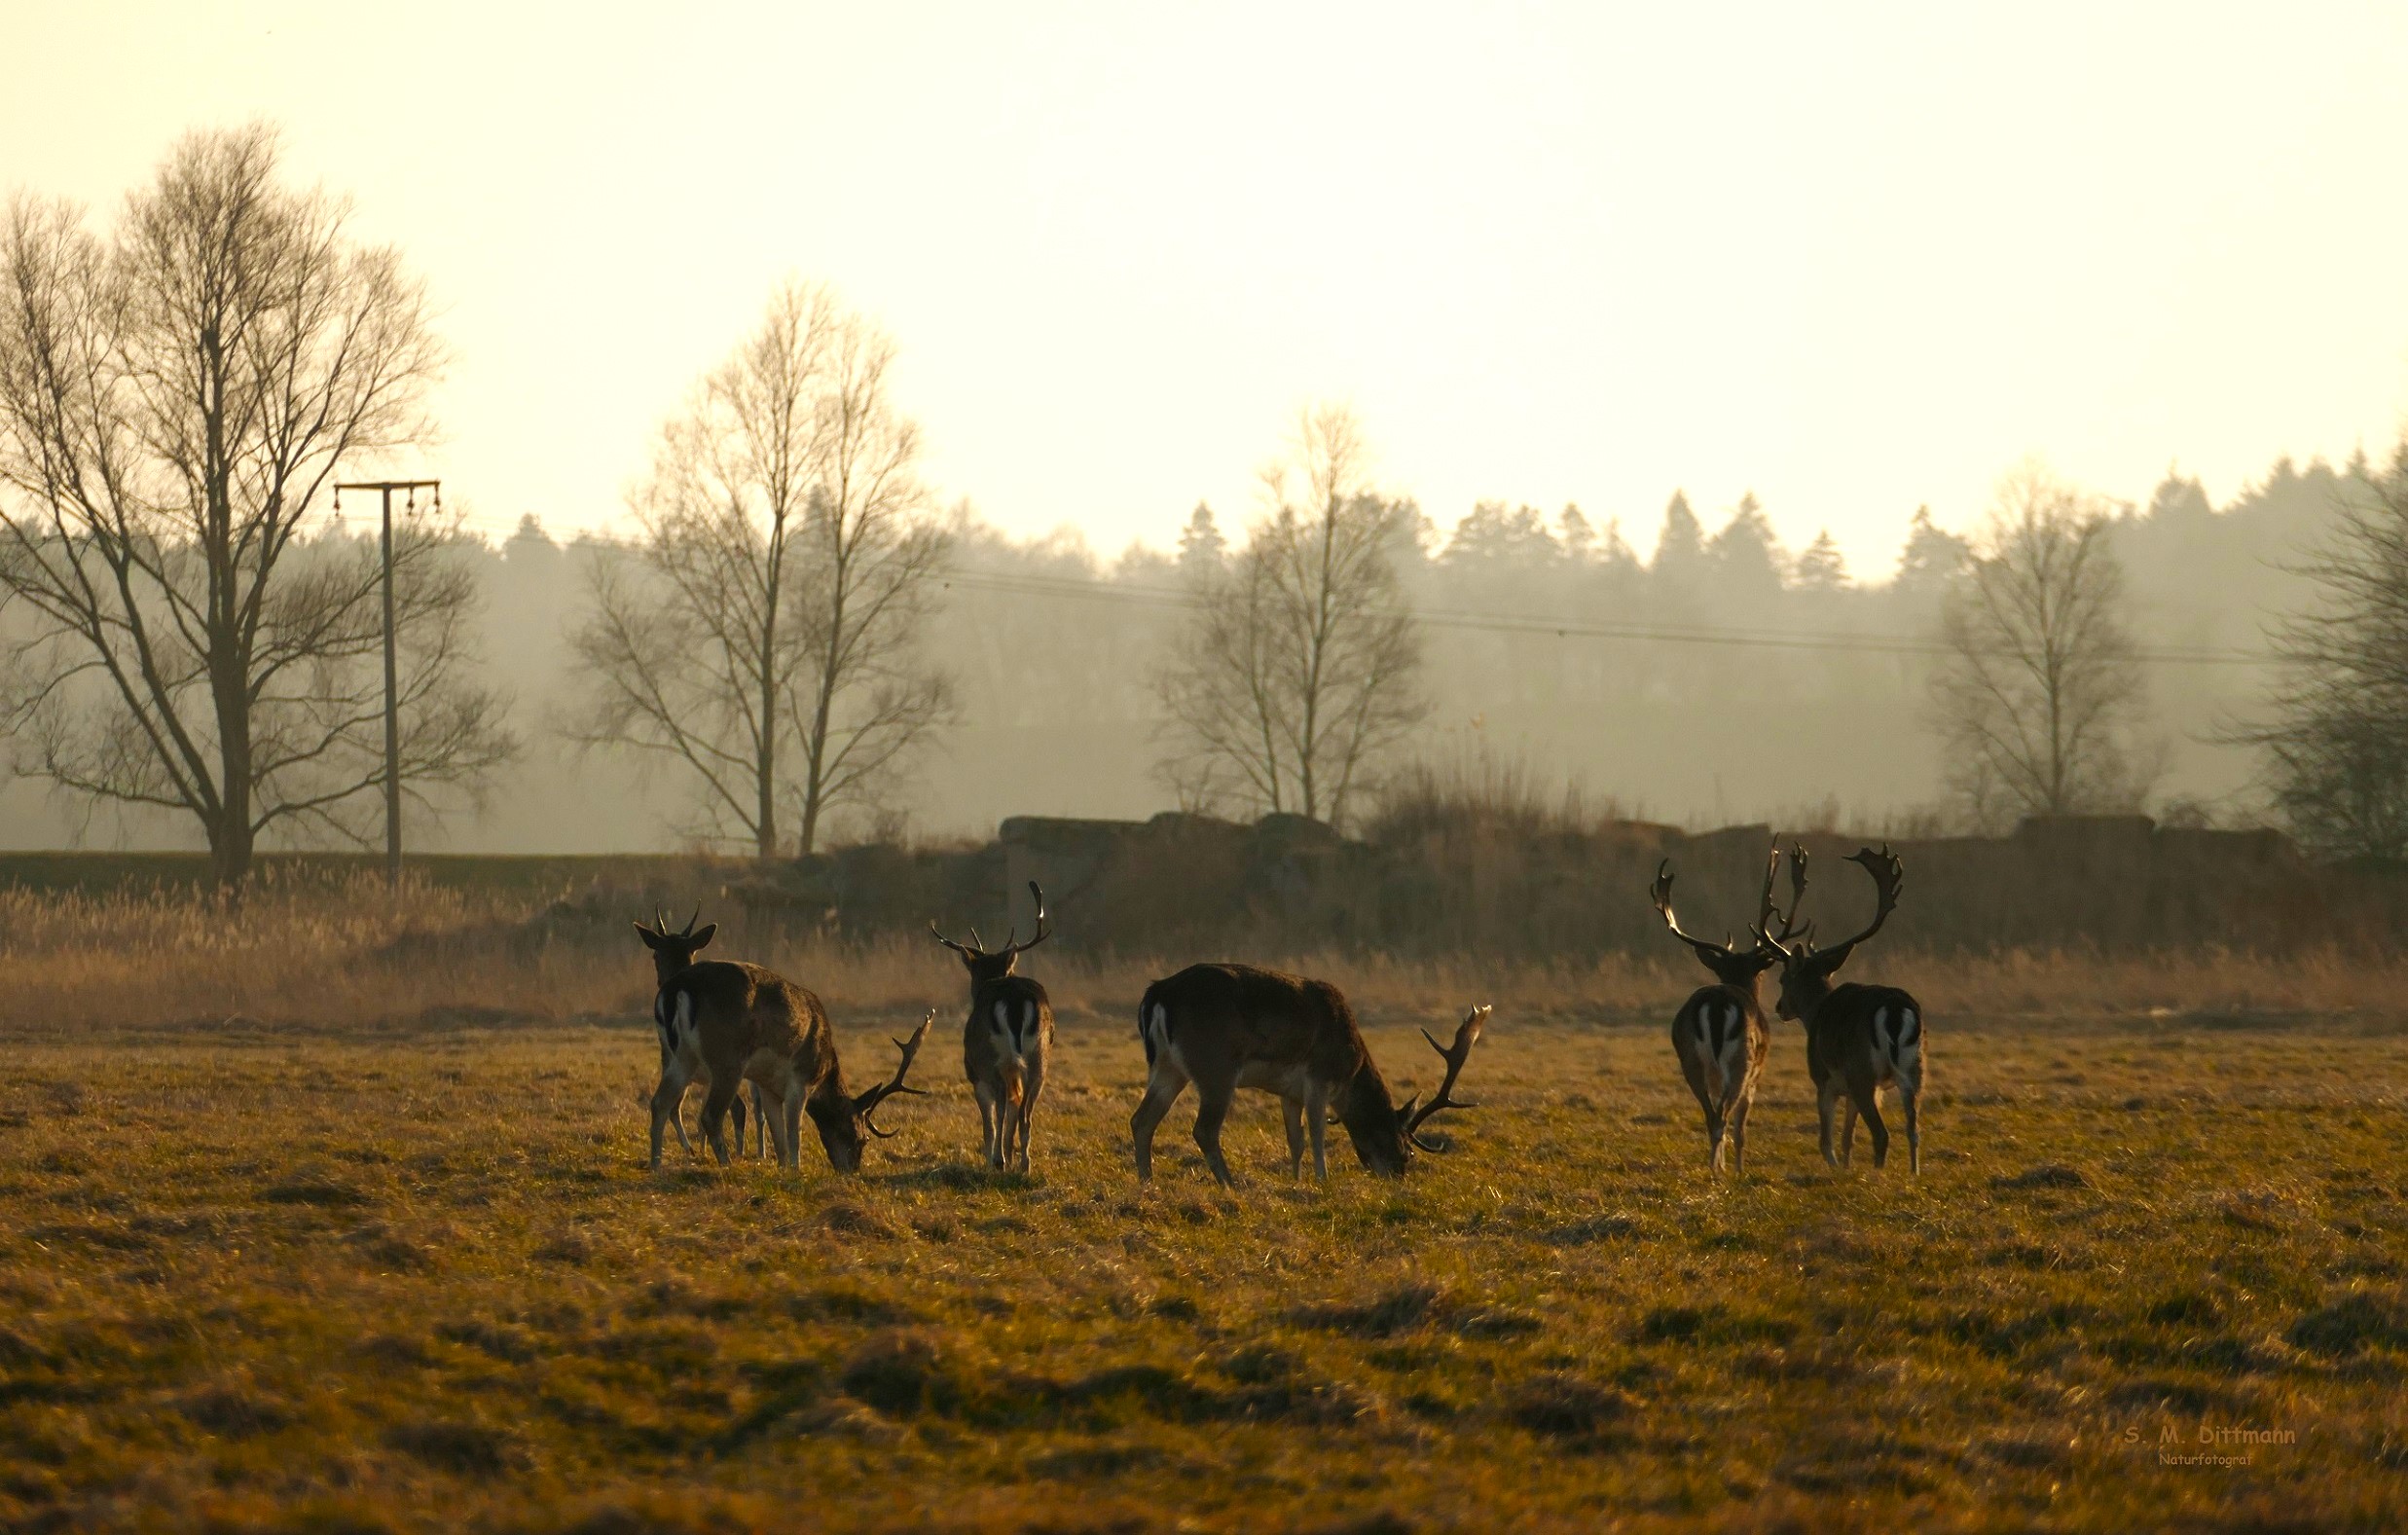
[14,875,2408,1039]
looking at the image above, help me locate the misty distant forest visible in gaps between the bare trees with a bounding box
[5,436,2351,853]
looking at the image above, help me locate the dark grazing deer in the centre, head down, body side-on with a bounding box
[1129,964,1488,1186]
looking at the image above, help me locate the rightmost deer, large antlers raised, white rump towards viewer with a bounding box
[1756,846,1924,1174]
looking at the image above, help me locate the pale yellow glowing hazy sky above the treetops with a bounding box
[0,0,2408,573]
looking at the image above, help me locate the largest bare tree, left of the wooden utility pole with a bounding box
[0,128,513,887]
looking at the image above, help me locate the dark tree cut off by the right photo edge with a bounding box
[2235,441,2408,858]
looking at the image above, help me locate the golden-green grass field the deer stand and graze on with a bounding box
[0,988,2408,1535]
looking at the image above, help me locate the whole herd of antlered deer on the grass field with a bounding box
[636,843,1924,1184]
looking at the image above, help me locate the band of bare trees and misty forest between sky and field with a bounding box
[0,126,2369,867]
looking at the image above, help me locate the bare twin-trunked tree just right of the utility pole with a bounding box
[570,284,951,858]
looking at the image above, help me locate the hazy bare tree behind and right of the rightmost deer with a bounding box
[1931,465,2153,824]
